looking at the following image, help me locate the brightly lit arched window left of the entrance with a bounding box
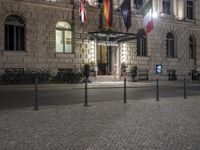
[56,21,72,53]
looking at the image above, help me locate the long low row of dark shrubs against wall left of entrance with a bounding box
[0,68,84,85]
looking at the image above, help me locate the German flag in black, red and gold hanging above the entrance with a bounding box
[103,0,113,29]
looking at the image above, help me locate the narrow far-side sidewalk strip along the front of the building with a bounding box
[0,80,200,90]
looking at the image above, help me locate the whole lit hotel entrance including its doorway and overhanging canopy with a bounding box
[88,28,137,77]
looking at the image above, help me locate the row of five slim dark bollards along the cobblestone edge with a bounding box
[34,78,187,110]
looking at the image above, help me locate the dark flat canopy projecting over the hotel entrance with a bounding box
[88,29,137,45]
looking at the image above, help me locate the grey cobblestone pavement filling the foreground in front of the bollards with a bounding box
[0,97,200,150]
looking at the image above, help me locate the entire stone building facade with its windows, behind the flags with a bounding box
[0,0,200,80]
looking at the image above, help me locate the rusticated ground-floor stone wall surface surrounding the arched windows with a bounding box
[0,0,200,79]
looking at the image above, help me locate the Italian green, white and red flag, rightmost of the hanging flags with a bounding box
[142,0,153,33]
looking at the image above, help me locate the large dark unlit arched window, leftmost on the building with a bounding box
[5,15,25,51]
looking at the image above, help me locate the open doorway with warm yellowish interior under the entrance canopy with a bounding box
[97,45,112,75]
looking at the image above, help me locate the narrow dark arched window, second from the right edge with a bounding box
[166,33,176,58]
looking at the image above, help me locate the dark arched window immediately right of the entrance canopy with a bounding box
[137,29,147,56]
